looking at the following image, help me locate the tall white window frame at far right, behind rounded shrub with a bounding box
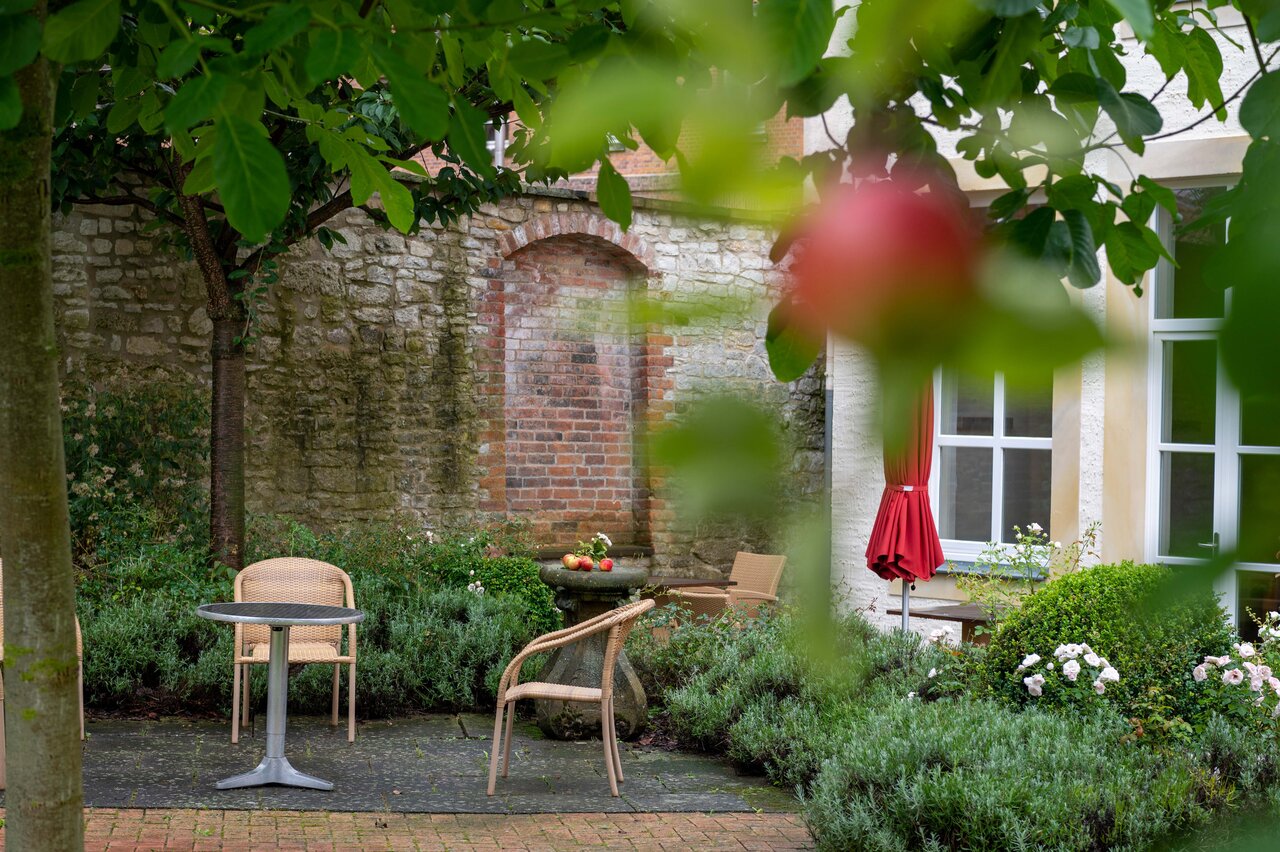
[1144,188,1280,624]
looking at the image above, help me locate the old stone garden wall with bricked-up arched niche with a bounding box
[54,185,823,572]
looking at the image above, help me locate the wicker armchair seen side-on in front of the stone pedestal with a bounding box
[489,600,653,796]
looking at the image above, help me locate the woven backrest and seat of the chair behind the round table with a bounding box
[236,556,356,645]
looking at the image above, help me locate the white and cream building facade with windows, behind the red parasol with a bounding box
[805,9,1280,632]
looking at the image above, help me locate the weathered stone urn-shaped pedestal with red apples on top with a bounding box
[534,565,649,739]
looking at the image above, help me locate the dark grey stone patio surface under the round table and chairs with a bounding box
[0,715,797,815]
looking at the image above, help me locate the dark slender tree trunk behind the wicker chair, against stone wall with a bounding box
[209,320,244,571]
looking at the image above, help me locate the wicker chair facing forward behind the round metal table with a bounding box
[232,556,356,742]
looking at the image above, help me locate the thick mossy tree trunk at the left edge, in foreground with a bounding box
[0,9,84,849]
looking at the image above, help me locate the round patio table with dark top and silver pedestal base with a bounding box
[196,601,365,789]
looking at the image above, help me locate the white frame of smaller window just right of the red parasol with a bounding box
[929,370,1053,563]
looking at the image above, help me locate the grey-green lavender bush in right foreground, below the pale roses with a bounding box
[805,700,1207,851]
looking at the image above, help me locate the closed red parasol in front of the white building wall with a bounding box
[867,385,946,629]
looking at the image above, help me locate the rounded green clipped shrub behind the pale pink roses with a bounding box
[986,562,1231,720]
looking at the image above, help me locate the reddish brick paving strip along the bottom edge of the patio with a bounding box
[0,809,814,852]
